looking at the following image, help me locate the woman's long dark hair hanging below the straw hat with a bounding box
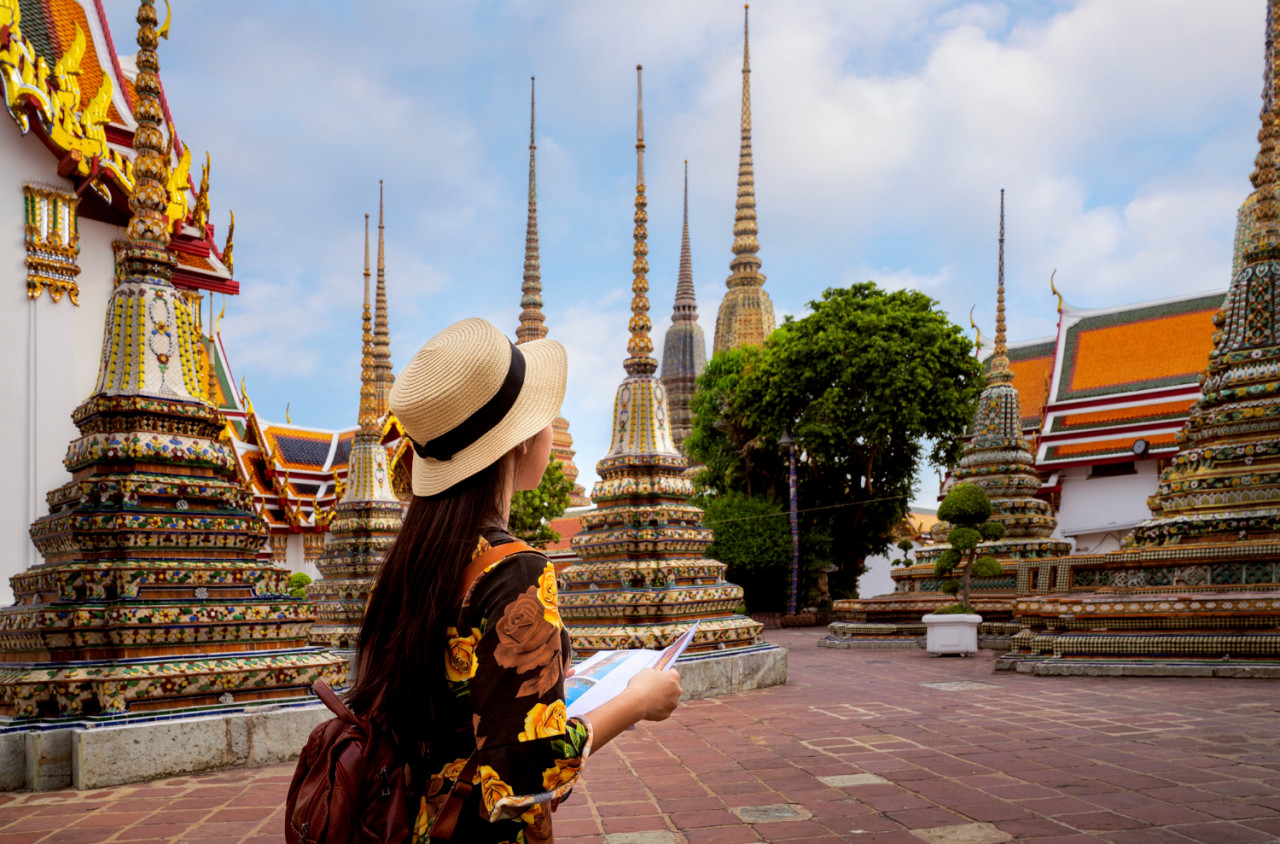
[346,452,515,768]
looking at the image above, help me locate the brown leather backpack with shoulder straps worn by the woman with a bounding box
[284,540,534,844]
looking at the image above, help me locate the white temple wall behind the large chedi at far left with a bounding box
[0,120,123,606]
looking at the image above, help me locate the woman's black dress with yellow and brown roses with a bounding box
[415,530,591,844]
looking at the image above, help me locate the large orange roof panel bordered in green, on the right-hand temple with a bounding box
[1056,295,1222,401]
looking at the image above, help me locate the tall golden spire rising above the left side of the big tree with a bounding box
[712,4,776,352]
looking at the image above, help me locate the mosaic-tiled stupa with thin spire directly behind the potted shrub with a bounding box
[828,191,1071,648]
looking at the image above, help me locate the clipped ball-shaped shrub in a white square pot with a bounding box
[922,484,1005,654]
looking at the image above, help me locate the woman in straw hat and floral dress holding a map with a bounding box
[347,319,680,844]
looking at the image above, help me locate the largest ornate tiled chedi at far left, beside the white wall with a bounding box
[0,0,346,718]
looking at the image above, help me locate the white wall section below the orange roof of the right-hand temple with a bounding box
[1057,460,1160,555]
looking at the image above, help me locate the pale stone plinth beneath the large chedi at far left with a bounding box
[0,698,332,791]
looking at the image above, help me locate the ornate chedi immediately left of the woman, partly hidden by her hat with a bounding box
[307,214,403,651]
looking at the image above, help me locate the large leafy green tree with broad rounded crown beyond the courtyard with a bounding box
[686,282,983,597]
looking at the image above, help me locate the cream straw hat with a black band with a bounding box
[390,318,568,496]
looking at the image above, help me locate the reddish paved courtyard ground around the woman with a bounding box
[0,629,1280,844]
